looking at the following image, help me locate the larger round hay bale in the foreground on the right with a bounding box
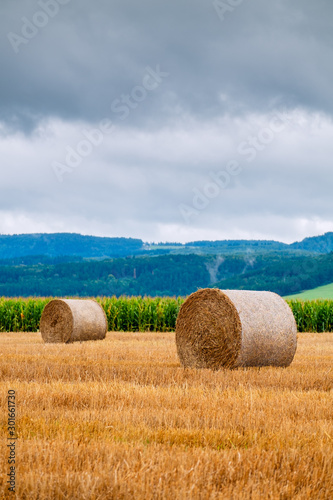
[176,288,297,369]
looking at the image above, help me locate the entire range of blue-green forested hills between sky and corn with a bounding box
[0,233,333,297]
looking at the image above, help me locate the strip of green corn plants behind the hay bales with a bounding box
[0,297,333,332]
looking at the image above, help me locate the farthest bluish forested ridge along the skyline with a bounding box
[0,233,333,260]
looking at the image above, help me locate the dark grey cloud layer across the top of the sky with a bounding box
[0,0,333,131]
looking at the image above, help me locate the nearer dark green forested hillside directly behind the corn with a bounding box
[0,253,333,297]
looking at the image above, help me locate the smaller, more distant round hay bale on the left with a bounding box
[40,299,108,343]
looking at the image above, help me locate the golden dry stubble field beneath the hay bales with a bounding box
[0,333,333,500]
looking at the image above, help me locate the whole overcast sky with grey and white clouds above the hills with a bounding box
[0,0,333,243]
